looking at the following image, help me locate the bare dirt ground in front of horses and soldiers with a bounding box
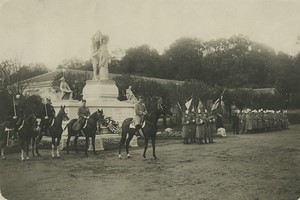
[0,125,300,200]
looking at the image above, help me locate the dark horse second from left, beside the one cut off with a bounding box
[15,114,41,161]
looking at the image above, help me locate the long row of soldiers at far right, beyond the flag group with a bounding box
[232,109,289,134]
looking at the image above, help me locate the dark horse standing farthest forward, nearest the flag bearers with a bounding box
[119,101,172,160]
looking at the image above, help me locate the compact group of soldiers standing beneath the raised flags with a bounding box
[182,109,216,144]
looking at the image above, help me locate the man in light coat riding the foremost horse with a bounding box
[134,96,148,136]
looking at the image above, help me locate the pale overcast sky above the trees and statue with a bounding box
[0,0,300,69]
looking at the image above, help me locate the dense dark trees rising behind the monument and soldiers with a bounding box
[58,35,300,106]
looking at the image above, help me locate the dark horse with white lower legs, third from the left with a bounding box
[48,106,69,158]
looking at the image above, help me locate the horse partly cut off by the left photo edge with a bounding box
[0,120,14,160]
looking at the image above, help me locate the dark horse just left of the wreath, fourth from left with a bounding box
[64,109,104,156]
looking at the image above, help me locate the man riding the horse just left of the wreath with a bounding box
[73,99,90,136]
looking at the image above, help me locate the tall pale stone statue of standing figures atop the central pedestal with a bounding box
[91,31,109,80]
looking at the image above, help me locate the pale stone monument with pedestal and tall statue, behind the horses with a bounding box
[53,31,137,150]
